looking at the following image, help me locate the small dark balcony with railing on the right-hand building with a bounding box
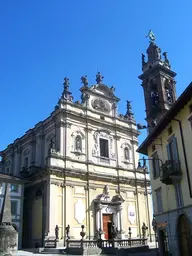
[160,160,182,185]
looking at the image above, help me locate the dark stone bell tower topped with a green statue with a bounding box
[139,30,176,132]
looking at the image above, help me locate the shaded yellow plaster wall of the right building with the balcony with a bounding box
[148,100,192,215]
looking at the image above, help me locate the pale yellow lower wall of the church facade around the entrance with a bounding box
[47,178,152,239]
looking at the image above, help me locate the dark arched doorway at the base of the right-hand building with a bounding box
[178,214,191,256]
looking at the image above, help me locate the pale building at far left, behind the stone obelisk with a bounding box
[0,173,24,249]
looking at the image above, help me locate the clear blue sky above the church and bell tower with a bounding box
[0,0,192,150]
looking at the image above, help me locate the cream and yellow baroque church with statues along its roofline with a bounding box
[1,72,152,248]
